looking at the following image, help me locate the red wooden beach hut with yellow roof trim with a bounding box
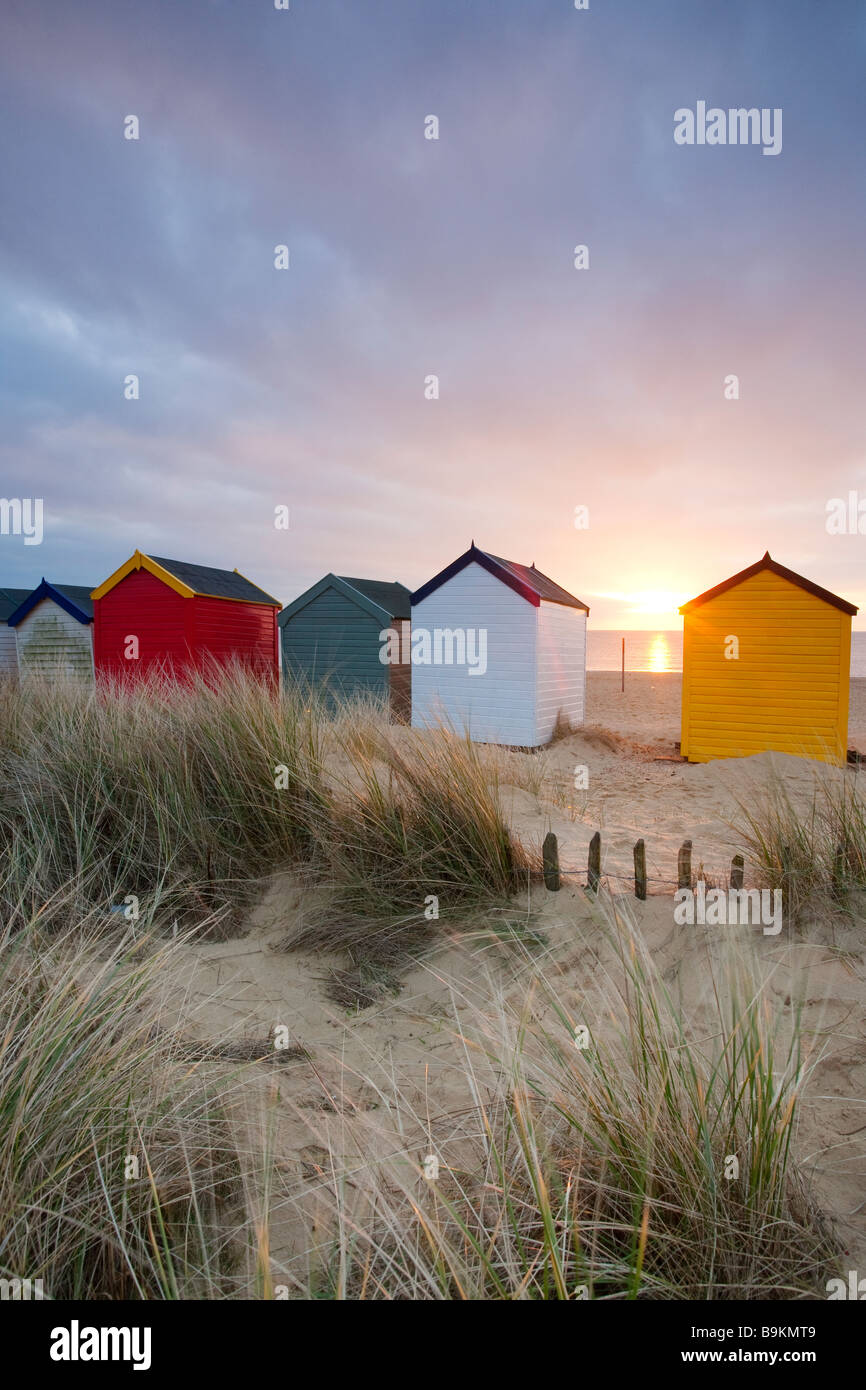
[92,550,281,678]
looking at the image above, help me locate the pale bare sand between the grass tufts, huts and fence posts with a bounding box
[145,673,866,1277]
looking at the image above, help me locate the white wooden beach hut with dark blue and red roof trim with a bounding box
[411,541,589,748]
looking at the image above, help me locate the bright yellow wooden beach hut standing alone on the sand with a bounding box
[680,550,858,763]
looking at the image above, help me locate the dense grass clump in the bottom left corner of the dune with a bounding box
[0,900,264,1300]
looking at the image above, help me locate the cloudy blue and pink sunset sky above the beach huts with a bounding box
[0,0,866,628]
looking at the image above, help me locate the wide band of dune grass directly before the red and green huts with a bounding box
[0,671,531,961]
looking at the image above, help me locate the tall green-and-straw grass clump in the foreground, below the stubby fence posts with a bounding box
[297,904,840,1301]
